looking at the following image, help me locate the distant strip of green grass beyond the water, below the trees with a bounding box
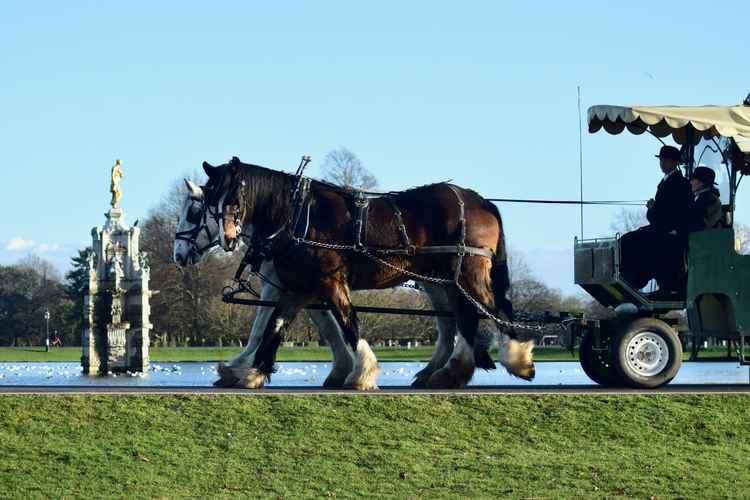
[0,346,740,363]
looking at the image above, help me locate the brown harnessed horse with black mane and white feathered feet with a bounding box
[203,158,534,388]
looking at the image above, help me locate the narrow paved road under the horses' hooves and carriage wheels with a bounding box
[0,384,750,397]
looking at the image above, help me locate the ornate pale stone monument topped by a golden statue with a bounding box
[81,160,152,375]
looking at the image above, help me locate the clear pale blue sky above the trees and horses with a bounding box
[0,0,750,293]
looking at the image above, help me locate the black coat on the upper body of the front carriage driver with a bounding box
[646,168,693,233]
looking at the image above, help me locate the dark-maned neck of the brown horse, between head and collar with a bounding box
[246,167,294,237]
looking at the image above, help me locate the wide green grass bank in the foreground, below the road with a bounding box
[0,395,750,498]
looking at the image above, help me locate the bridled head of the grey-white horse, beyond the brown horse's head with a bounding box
[172,179,219,266]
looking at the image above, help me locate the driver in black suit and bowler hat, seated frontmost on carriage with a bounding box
[620,146,693,292]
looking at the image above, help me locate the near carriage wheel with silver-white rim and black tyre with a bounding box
[612,318,682,389]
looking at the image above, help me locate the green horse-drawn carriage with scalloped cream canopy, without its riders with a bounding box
[572,102,750,388]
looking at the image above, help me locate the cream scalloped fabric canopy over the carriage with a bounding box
[589,106,750,153]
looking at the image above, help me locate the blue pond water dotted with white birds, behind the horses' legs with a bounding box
[0,362,750,387]
